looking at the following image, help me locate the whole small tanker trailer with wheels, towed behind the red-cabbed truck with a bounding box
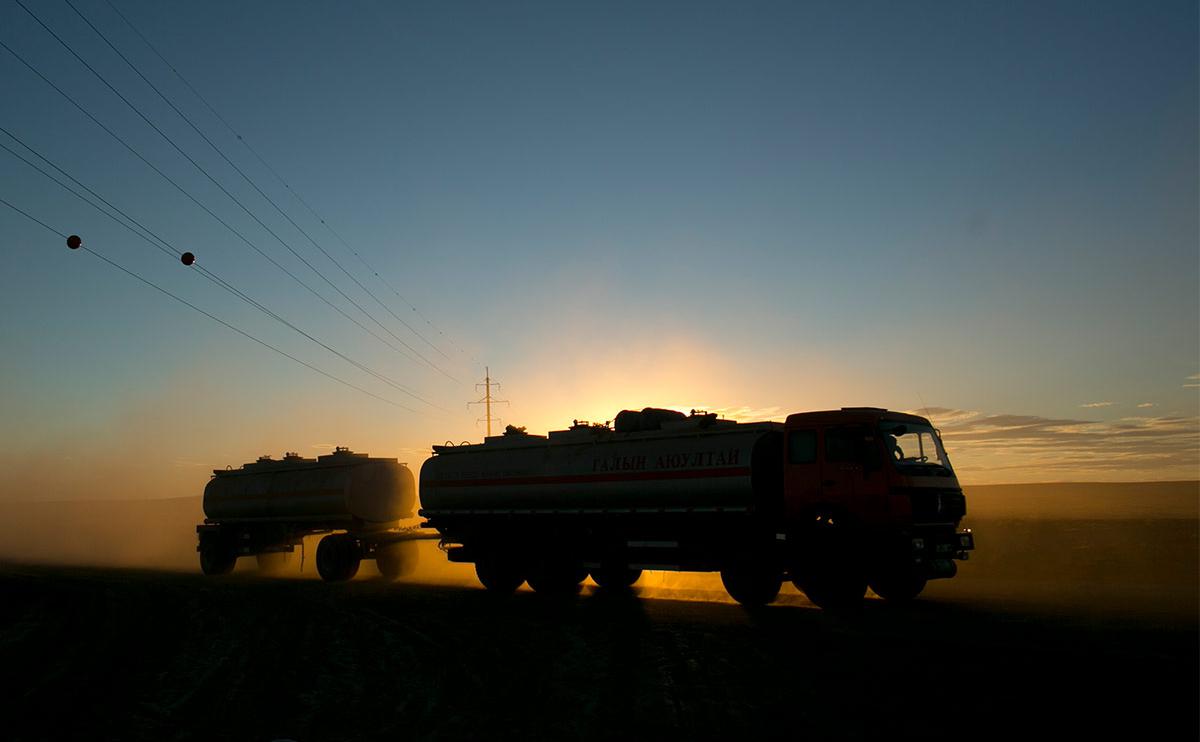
[196,447,428,581]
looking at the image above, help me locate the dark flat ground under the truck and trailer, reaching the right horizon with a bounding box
[0,511,1200,742]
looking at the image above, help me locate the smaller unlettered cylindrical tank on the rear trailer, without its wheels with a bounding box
[204,449,416,527]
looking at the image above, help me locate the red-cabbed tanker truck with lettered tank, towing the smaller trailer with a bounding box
[419,407,974,608]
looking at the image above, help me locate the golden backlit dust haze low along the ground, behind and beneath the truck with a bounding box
[0,481,1200,614]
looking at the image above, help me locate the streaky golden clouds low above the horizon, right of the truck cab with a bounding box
[916,402,1200,483]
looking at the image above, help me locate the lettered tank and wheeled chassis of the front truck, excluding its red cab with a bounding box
[420,408,782,599]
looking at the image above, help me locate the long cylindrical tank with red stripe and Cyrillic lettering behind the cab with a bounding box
[421,415,779,516]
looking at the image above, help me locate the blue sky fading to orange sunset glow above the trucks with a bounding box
[0,0,1200,499]
